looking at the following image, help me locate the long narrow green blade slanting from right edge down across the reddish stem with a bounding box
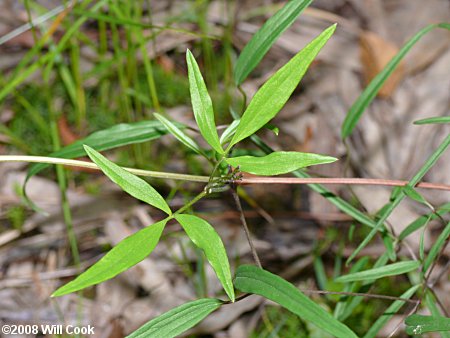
[347,135,450,264]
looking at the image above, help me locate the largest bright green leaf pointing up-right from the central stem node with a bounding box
[228,25,336,150]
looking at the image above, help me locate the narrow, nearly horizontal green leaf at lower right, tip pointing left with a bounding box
[335,261,420,283]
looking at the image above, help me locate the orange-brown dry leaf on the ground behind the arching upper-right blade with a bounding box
[359,31,405,98]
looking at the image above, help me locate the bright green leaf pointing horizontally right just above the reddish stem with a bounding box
[226,151,337,176]
